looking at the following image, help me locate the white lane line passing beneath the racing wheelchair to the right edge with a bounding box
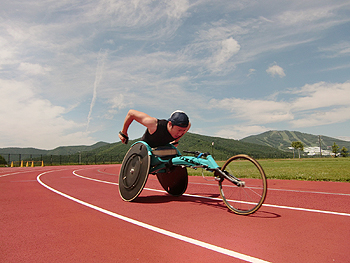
[73,170,350,216]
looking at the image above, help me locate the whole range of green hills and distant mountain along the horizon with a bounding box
[0,131,350,164]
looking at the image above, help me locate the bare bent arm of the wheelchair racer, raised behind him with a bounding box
[119,110,158,143]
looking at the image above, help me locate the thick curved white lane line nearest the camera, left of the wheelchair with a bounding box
[37,171,268,263]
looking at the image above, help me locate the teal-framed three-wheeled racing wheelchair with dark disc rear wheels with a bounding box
[119,141,267,215]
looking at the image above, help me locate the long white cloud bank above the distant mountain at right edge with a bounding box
[209,82,350,131]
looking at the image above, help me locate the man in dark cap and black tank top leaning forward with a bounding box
[119,110,191,148]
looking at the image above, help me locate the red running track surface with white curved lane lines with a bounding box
[0,165,350,262]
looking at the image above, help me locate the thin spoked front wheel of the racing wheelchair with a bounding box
[219,154,267,215]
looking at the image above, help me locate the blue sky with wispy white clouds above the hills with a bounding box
[0,0,350,149]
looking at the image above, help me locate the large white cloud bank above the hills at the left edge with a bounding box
[0,80,94,149]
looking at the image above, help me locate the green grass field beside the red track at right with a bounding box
[188,158,350,182]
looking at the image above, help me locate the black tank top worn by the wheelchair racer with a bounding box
[141,120,175,148]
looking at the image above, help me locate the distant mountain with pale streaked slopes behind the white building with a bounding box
[240,131,350,151]
